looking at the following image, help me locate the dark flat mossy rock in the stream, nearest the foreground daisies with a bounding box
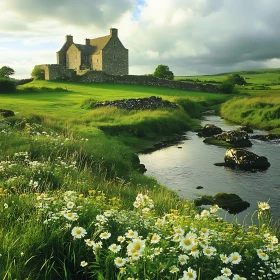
[194,193,250,214]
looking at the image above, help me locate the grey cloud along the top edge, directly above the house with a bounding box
[7,0,133,27]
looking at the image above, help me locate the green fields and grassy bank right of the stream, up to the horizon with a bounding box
[177,69,280,134]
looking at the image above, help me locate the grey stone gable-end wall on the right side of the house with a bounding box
[102,36,128,75]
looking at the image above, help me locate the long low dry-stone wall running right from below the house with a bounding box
[77,71,221,93]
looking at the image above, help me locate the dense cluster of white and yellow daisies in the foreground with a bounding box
[36,191,280,280]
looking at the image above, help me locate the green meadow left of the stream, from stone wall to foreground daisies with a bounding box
[0,77,280,280]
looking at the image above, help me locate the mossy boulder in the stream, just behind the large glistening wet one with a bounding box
[203,130,252,148]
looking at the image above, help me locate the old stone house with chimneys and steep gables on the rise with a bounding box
[57,28,128,75]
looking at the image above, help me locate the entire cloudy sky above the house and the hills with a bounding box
[0,0,280,78]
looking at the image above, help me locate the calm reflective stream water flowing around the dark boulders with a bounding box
[139,115,280,222]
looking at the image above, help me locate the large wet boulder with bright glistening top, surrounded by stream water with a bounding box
[224,148,270,170]
